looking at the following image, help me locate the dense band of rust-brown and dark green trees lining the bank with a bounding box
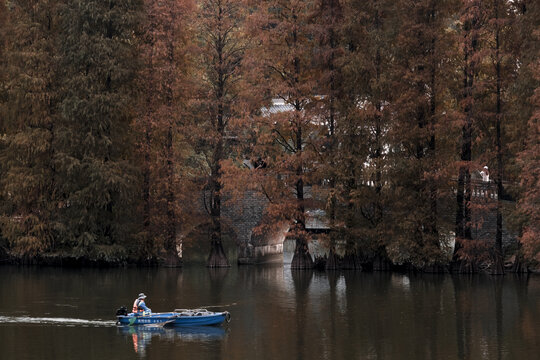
[0,0,540,274]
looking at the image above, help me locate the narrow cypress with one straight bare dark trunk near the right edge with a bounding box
[481,0,525,275]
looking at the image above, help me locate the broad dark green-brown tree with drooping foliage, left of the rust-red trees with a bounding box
[54,0,141,261]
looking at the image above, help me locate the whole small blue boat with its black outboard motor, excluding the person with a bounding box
[116,308,231,326]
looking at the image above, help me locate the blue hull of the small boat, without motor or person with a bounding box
[117,311,229,326]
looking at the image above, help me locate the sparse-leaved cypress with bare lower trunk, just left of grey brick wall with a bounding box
[186,0,246,267]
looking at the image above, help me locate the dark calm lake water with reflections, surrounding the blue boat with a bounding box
[0,266,540,360]
